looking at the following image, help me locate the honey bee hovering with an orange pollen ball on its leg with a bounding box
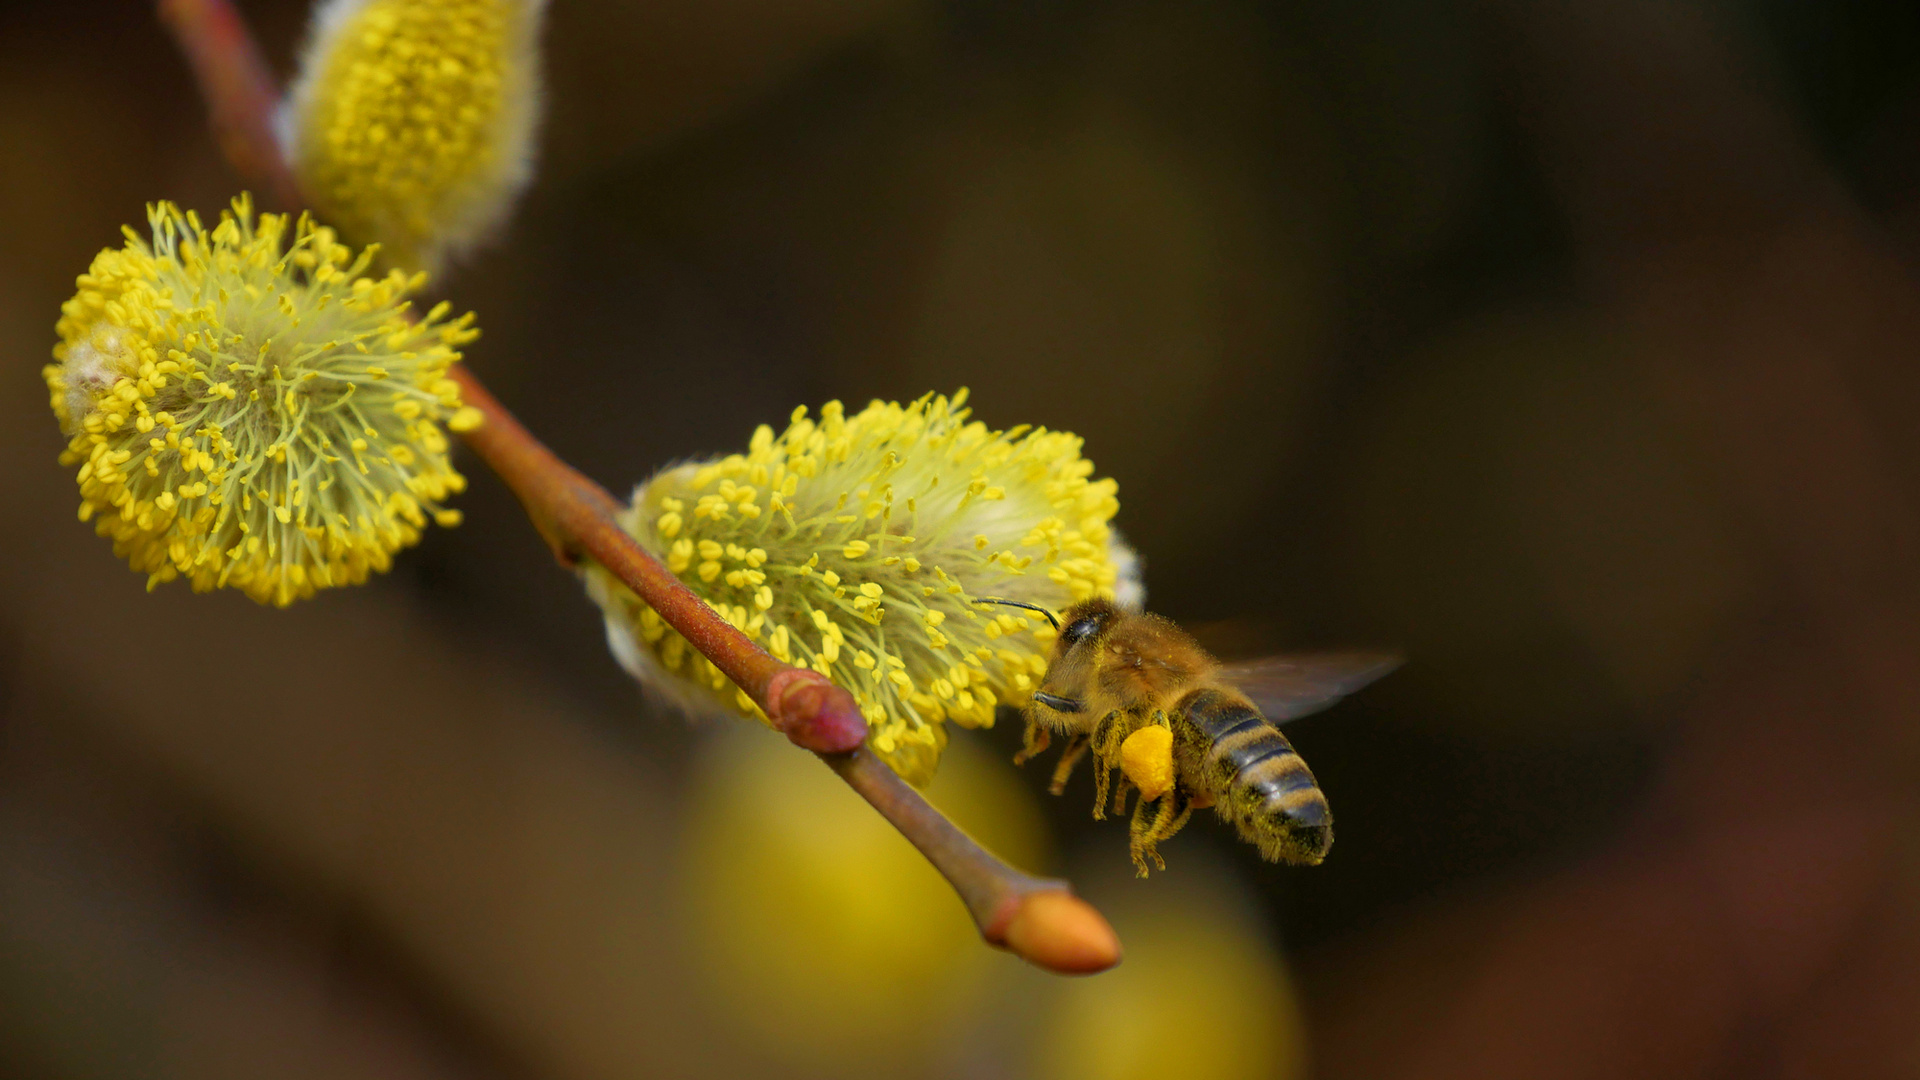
[981,600,1400,878]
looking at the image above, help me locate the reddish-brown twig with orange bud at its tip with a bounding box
[159,0,1119,974]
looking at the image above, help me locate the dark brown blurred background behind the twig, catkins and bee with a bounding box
[0,0,1920,1080]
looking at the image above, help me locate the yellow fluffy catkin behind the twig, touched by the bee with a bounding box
[588,390,1139,782]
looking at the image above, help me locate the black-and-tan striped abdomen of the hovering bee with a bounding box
[1179,688,1332,863]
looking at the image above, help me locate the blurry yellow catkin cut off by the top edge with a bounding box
[284,0,543,269]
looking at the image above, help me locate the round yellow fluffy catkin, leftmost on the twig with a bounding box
[44,196,476,605]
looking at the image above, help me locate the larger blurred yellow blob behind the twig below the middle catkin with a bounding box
[682,724,1046,1067]
